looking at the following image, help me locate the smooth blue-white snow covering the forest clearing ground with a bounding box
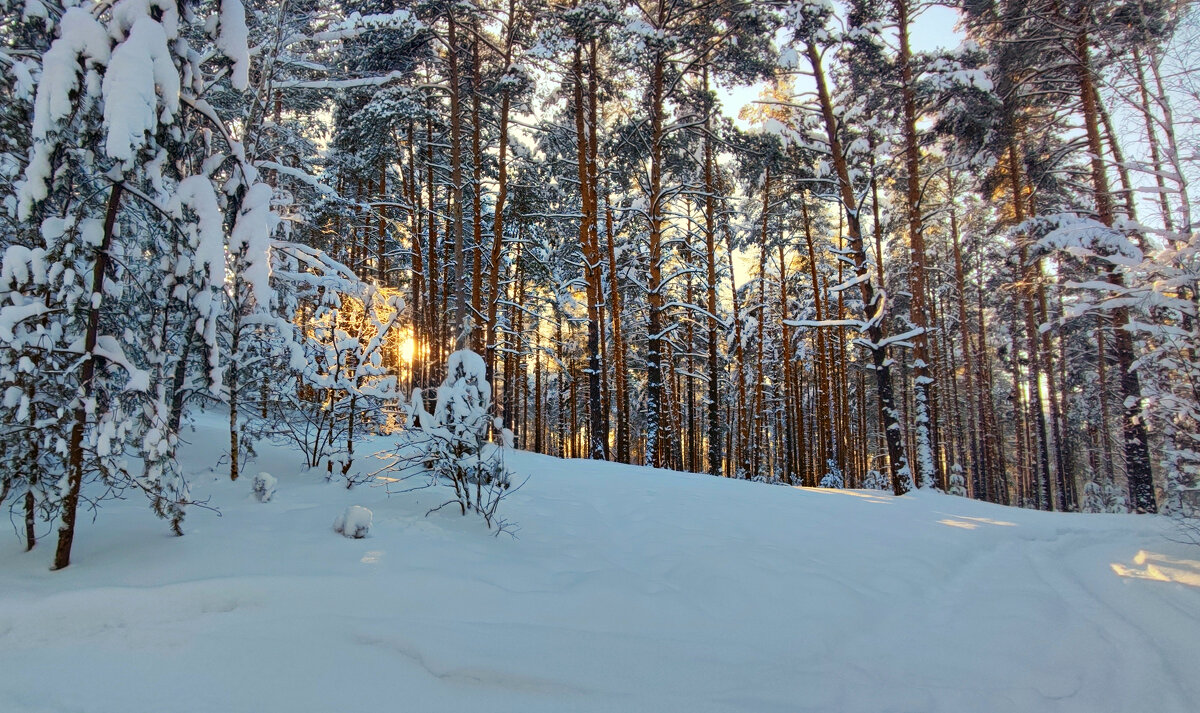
[0,417,1200,713]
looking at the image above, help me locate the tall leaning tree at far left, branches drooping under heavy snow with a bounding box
[0,0,221,561]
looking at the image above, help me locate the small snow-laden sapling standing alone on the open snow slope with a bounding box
[384,349,518,532]
